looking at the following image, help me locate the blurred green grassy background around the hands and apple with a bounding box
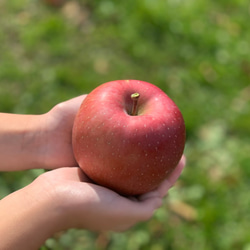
[0,0,250,250]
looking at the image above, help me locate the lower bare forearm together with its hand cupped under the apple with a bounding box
[0,157,185,250]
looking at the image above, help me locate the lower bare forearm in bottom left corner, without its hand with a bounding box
[0,181,59,250]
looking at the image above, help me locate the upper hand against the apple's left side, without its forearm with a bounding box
[41,95,87,169]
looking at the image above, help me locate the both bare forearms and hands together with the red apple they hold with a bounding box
[0,80,185,250]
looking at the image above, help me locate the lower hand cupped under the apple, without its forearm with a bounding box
[35,156,185,231]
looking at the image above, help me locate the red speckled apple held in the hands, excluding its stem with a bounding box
[72,80,186,195]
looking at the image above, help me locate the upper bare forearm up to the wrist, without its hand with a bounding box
[0,113,44,171]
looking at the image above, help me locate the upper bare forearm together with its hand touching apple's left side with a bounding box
[0,95,86,171]
